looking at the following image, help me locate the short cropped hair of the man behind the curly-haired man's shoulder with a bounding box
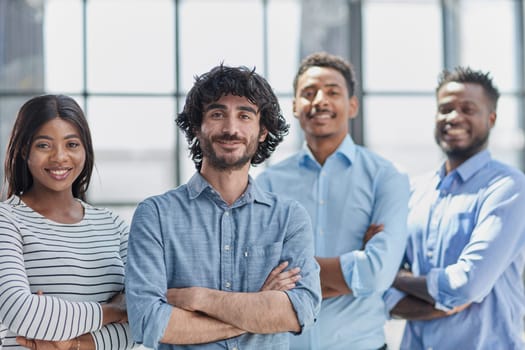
[293,52,357,97]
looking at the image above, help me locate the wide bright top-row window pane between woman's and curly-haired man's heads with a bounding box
[87,0,175,93]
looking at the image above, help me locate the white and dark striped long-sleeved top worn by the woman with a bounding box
[0,196,134,350]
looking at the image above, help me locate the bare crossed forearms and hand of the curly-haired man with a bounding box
[161,262,301,344]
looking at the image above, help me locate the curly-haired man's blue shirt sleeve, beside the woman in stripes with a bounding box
[126,201,172,348]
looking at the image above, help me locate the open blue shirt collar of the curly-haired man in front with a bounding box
[188,172,271,205]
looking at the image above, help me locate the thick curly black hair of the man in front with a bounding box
[176,64,289,171]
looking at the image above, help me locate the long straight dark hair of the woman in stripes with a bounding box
[4,95,95,200]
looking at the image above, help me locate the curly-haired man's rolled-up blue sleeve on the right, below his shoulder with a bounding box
[281,203,322,332]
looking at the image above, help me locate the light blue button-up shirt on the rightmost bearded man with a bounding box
[386,150,525,350]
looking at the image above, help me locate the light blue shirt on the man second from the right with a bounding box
[257,136,409,350]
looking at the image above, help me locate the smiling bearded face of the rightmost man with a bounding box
[434,82,496,169]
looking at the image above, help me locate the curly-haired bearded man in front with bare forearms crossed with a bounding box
[126,65,321,350]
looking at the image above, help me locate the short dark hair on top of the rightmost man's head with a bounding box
[436,66,500,111]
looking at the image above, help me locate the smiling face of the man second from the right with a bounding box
[293,66,358,145]
